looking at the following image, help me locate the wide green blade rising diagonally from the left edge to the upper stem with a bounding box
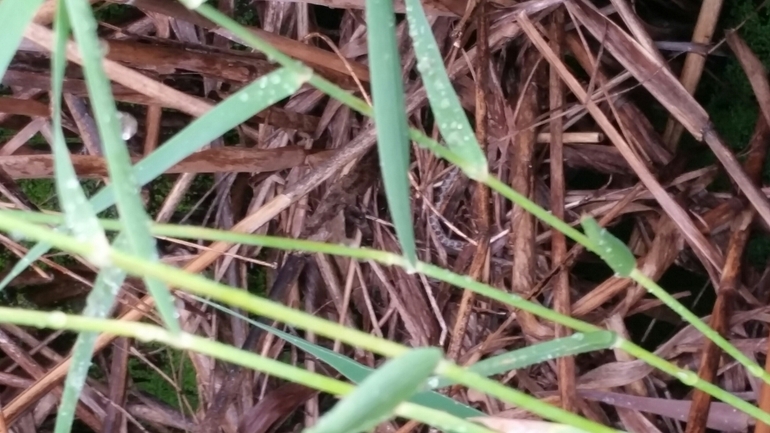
[0,68,312,290]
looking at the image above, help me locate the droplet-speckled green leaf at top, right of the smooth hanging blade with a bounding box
[402,0,488,180]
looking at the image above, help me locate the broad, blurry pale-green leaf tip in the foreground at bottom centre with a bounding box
[305,347,442,433]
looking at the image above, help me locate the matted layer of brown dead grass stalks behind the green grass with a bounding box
[0,0,770,433]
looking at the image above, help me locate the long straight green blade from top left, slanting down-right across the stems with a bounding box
[64,0,181,332]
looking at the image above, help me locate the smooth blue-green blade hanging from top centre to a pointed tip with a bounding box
[366,0,417,263]
